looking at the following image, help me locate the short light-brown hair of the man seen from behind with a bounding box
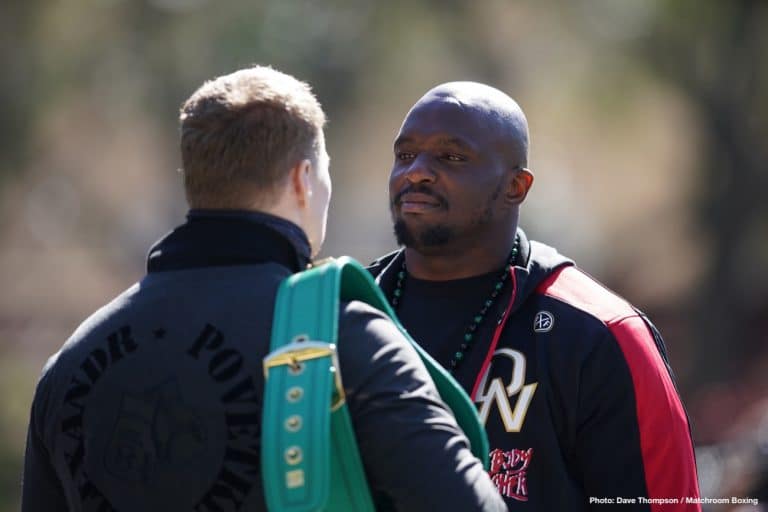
[180,66,325,209]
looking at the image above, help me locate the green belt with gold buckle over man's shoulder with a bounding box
[261,257,488,512]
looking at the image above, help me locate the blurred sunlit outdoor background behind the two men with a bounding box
[0,0,768,511]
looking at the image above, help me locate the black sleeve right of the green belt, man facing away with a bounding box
[339,302,506,511]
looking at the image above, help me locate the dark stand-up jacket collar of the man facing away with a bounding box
[147,210,311,273]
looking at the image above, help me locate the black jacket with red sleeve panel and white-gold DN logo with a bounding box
[370,231,700,512]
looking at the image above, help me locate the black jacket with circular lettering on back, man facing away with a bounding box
[22,211,504,512]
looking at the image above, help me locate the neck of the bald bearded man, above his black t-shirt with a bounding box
[405,229,516,281]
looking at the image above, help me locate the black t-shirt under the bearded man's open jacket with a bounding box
[397,269,510,393]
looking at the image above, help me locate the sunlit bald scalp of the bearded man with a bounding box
[406,82,528,167]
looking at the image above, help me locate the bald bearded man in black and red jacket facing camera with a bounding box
[370,82,699,512]
